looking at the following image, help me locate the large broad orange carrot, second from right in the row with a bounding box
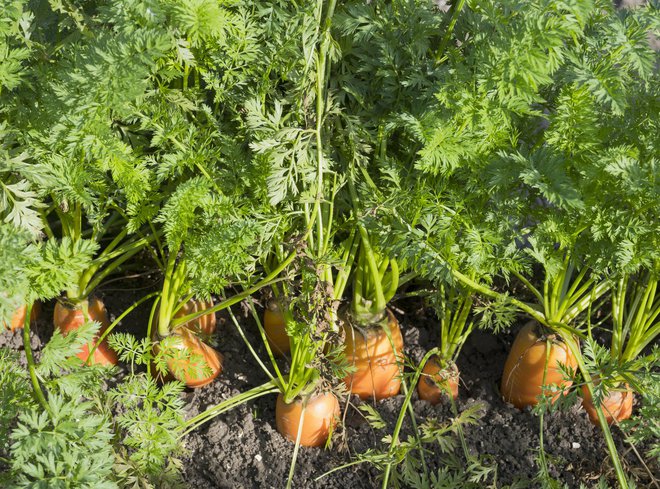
[501,321,577,409]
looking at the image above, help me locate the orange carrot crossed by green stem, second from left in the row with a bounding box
[53,298,118,365]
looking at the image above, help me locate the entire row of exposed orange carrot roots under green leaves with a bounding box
[9,292,633,446]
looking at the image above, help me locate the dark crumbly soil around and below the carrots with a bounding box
[0,279,658,489]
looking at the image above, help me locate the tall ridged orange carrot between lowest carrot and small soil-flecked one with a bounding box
[344,310,403,400]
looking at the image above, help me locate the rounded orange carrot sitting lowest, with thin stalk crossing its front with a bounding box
[275,392,339,447]
